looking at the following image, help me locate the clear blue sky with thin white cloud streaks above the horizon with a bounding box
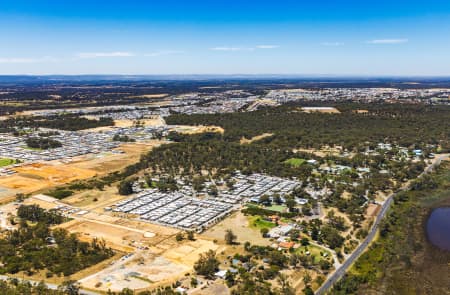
[0,0,450,76]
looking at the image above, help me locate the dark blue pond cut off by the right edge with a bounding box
[427,207,450,251]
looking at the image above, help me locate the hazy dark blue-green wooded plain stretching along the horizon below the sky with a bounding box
[0,76,450,115]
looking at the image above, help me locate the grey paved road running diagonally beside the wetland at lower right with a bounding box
[315,154,449,295]
